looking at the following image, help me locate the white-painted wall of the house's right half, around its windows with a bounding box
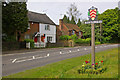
[39,23,56,43]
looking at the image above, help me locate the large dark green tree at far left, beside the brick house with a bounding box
[2,2,28,41]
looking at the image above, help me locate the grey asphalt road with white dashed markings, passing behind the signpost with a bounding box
[2,44,118,76]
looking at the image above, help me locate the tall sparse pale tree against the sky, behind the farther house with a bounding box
[66,3,81,22]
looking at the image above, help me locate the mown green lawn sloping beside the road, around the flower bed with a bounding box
[3,48,118,78]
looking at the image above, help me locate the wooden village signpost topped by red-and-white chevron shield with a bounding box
[85,6,102,65]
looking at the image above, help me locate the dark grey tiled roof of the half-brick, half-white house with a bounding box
[28,11,55,25]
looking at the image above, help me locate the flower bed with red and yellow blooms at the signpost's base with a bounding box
[78,61,107,74]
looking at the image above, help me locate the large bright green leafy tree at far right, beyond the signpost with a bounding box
[98,8,119,42]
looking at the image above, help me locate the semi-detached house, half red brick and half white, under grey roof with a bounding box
[20,11,56,47]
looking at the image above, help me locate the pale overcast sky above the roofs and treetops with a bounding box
[27,0,119,25]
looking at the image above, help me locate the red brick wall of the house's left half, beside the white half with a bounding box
[20,22,39,41]
